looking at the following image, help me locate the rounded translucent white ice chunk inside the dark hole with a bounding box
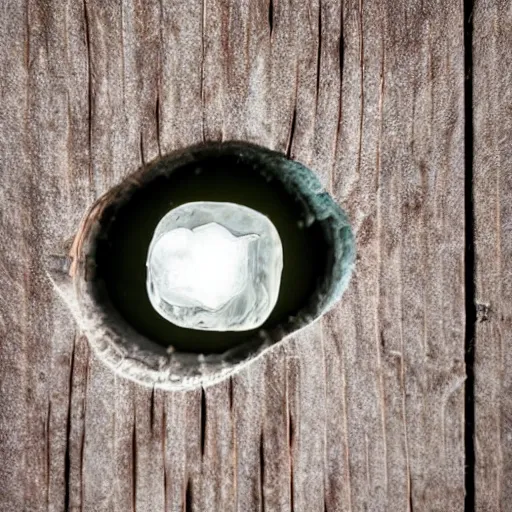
[147,202,283,331]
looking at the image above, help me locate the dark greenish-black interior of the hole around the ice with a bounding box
[96,151,329,354]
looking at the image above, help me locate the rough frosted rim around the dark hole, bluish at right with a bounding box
[49,141,355,390]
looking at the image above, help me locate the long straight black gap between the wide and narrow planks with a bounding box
[464,0,477,511]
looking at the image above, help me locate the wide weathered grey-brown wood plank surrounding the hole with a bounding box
[0,0,470,512]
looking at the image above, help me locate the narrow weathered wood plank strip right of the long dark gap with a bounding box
[473,0,512,511]
